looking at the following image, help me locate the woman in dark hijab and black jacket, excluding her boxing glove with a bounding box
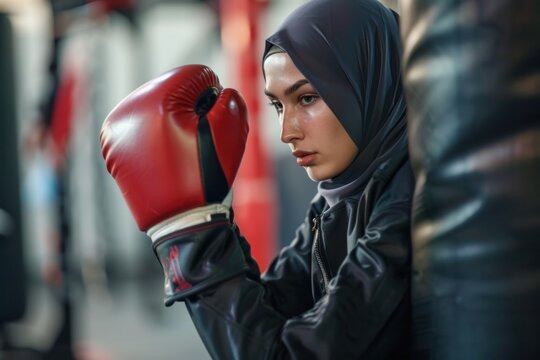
[194,0,414,359]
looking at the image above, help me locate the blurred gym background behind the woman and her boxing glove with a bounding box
[0,0,397,360]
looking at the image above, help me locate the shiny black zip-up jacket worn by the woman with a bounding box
[182,153,414,360]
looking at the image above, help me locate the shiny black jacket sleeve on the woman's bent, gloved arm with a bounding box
[185,172,411,359]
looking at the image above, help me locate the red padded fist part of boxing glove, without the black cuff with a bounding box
[100,65,248,233]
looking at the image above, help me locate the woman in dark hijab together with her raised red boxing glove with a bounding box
[101,0,414,359]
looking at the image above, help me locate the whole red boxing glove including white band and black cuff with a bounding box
[100,65,249,306]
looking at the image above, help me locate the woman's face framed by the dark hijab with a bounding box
[264,52,358,181]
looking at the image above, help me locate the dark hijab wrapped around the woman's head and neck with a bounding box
[263,0,407,206]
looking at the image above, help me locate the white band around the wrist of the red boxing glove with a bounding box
[146,204,230,243]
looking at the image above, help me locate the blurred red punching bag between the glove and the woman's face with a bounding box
[220,0,278,271]
